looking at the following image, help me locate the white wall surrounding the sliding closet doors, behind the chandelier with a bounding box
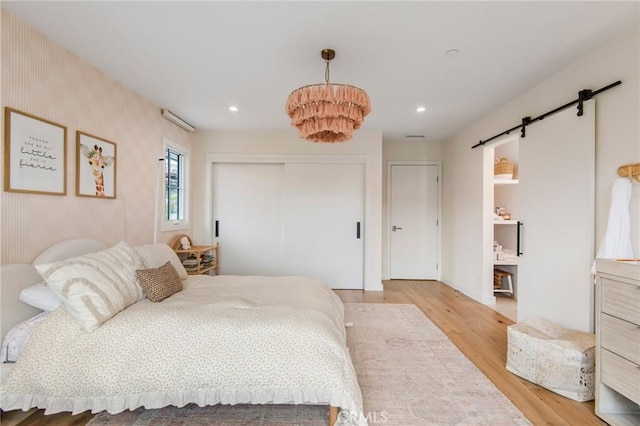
[191,129,382,290]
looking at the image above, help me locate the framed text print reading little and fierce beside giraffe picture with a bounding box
[4,107,67,195]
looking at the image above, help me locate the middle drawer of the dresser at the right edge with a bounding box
[600,314,640,365]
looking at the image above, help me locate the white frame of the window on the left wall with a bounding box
[160,138,191,232]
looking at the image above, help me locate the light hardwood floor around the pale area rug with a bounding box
[1,280,606,426]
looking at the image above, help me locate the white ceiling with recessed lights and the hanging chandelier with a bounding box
[2,1,640,142]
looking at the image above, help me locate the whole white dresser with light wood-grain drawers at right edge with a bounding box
[596,259,640,426]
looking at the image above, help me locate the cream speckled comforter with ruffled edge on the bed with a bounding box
[0,276,362,417]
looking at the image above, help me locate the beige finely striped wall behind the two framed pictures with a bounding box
[0,10,191,264]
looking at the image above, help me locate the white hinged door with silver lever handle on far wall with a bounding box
[389,164,438,280]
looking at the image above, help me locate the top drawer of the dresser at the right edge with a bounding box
[600,277,640,325]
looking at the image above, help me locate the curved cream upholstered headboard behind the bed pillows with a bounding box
[0,238,107,341]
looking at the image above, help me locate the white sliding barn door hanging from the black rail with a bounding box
[518,100,595,331]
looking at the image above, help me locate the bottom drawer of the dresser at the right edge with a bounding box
[600,349,640,404]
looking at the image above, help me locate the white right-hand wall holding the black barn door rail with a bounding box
[443,32,640,301]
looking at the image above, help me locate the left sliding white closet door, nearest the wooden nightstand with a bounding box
[213,163,284,276]
